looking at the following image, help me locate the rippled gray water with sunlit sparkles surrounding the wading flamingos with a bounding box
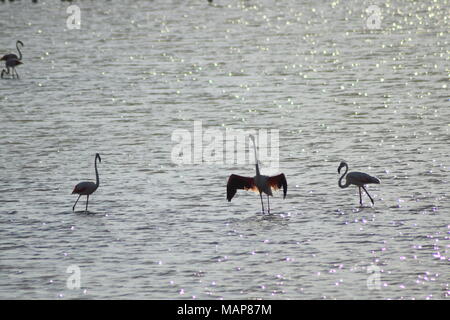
[0,0,450,299]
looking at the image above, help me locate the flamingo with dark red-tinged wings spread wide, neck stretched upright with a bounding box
[227,135,287,214]
